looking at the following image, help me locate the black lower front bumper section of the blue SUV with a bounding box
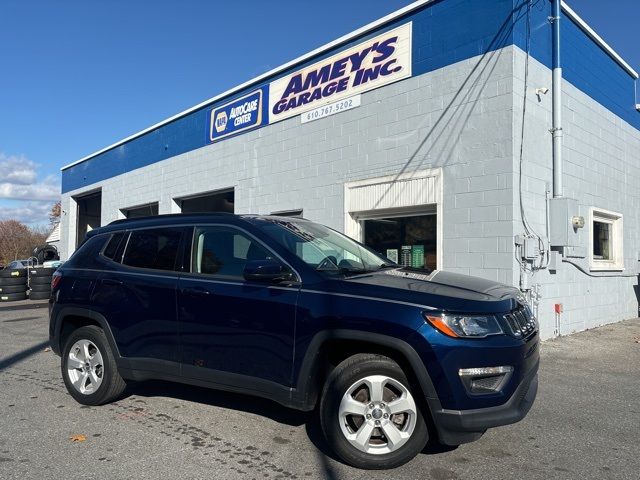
[433,363,539,445]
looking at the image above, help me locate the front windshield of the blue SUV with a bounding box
[257,218,396,274]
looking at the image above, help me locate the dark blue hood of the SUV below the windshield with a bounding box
[344,268,519,313]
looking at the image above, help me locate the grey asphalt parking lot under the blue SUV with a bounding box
[0,301,640,480]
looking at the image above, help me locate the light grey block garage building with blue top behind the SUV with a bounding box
[60,0,640,338]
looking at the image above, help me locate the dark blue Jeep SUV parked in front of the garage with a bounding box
[50,214,539,468]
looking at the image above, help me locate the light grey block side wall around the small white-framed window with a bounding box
[513,48,640,338]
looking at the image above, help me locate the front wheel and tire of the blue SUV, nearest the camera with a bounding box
[320,354,429,469]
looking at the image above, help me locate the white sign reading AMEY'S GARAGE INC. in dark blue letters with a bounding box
[269,22,412,123]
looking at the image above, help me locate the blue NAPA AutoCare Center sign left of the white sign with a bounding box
[207,89,267,142]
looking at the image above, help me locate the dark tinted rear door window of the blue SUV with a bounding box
[122,228,184,270]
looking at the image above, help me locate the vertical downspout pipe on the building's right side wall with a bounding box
[549,0,563,198]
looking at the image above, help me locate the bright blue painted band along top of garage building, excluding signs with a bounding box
[62,0,640,193]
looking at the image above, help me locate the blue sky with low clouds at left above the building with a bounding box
[0,0,640,224]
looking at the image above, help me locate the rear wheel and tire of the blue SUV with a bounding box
[61,325,126,405]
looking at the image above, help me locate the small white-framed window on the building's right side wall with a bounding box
[589,208,624,270]
